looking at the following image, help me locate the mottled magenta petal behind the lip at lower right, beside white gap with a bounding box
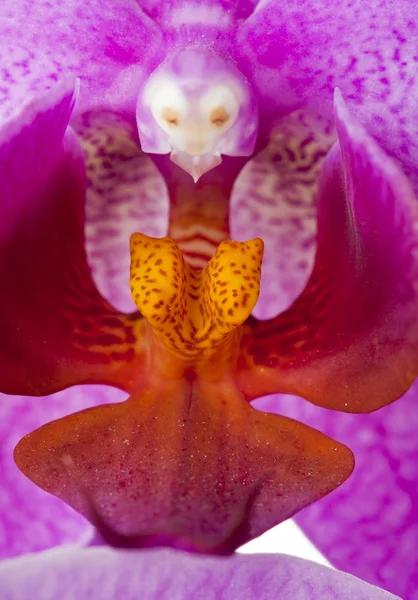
[255,384,418,600]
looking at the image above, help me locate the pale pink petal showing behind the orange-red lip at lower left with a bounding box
[0,386,125,558]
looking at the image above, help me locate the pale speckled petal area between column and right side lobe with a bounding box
[230,111,336,319]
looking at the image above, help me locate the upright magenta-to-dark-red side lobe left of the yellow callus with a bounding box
[0,85,142,395]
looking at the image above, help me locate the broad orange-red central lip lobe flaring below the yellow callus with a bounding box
[14,378,353,554]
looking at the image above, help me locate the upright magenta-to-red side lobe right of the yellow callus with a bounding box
[237,94,418,412]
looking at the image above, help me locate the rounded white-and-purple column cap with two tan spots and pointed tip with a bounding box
[137,49,258,181]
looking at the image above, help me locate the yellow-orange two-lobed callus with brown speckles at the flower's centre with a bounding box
[131,233,263,361]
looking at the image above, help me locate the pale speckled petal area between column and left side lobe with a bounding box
[73,111,168,312]
